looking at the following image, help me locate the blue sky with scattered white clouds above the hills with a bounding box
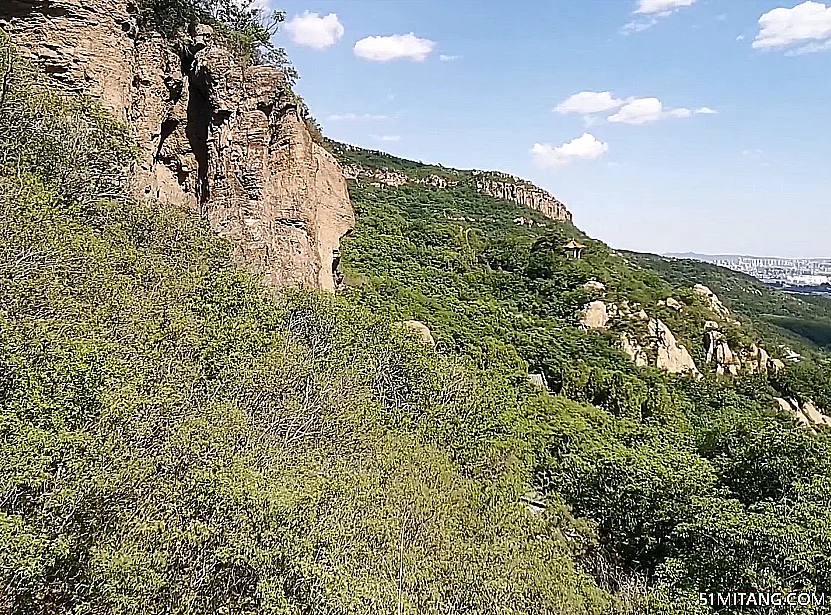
[272,0,831,256]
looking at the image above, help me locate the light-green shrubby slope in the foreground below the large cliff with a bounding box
[0,30,619,614]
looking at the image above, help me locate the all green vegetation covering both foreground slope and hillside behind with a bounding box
[0,7,831,615]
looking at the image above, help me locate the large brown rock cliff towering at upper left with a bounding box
[0,0,354,289]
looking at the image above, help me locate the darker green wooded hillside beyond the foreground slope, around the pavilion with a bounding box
[334,147,831,613]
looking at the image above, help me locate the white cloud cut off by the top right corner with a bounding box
[753,1,831,53]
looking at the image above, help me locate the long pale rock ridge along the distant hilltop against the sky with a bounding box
[344,164,572,222]
